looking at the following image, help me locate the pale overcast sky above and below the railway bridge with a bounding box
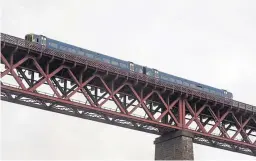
[1,0,256,160]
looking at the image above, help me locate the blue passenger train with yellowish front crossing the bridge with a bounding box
[25,33,233,99]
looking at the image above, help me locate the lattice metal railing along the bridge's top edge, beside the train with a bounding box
[0,33,256,113]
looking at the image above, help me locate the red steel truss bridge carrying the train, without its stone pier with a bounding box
[1,33,256,156]
